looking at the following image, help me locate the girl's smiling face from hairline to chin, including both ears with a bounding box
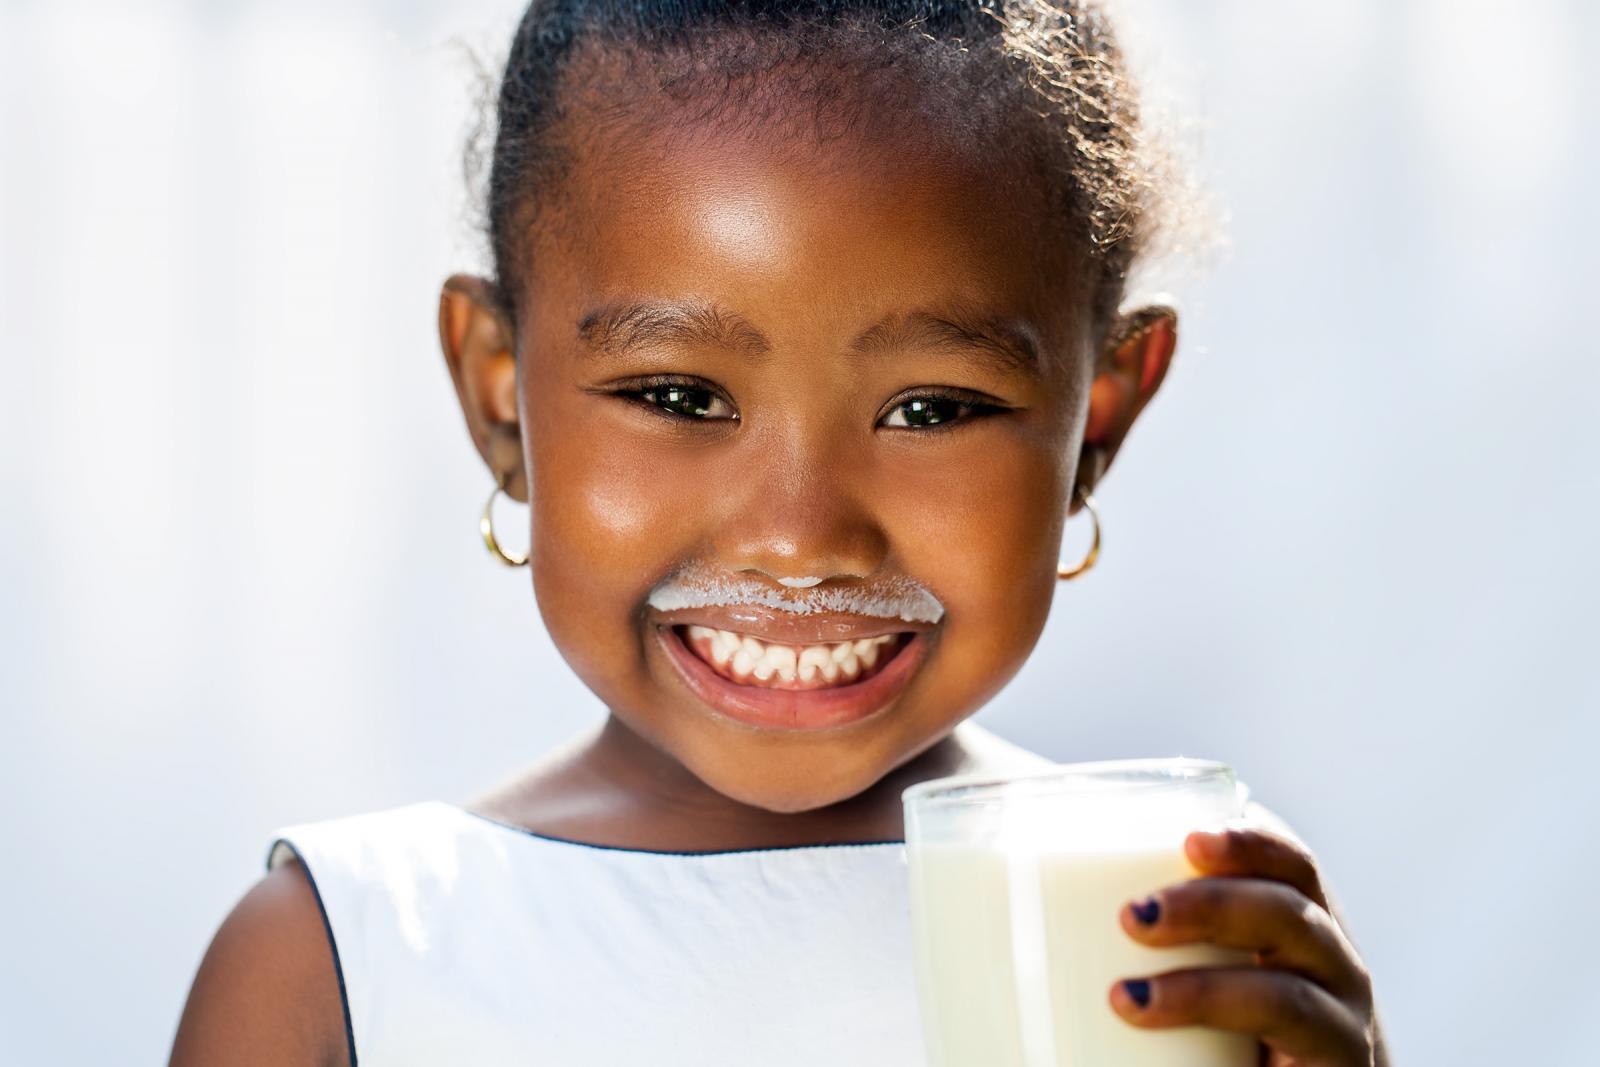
[442,102,1171,811]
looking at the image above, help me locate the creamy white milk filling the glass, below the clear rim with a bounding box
[907,845,1256,1067]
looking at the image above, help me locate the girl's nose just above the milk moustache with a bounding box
[714,432,890,585]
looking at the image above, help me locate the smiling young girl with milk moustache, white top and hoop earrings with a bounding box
[173,0,1384,1067]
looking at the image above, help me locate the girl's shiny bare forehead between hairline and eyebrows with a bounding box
[523,92,1082,362]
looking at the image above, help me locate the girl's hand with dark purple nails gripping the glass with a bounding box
[1110,830,1387,1067]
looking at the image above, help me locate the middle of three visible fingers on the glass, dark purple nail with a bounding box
[1122,878,1365,997]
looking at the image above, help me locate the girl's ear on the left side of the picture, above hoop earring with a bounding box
[438,274,528,502]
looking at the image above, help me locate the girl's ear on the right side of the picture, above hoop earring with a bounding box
[1078,304,1178,502]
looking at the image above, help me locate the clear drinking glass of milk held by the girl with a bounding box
[902,758,1256,1067]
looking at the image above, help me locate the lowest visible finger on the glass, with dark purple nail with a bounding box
[1110,968,1371,1067]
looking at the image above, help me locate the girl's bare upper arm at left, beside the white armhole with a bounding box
[171,859,349,1067]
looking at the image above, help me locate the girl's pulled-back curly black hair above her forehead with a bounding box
[478,0,1160,342]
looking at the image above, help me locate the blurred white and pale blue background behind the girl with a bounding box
[0,0,1600,1067]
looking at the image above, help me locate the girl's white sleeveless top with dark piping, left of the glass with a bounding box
[267,800,926,1067]
